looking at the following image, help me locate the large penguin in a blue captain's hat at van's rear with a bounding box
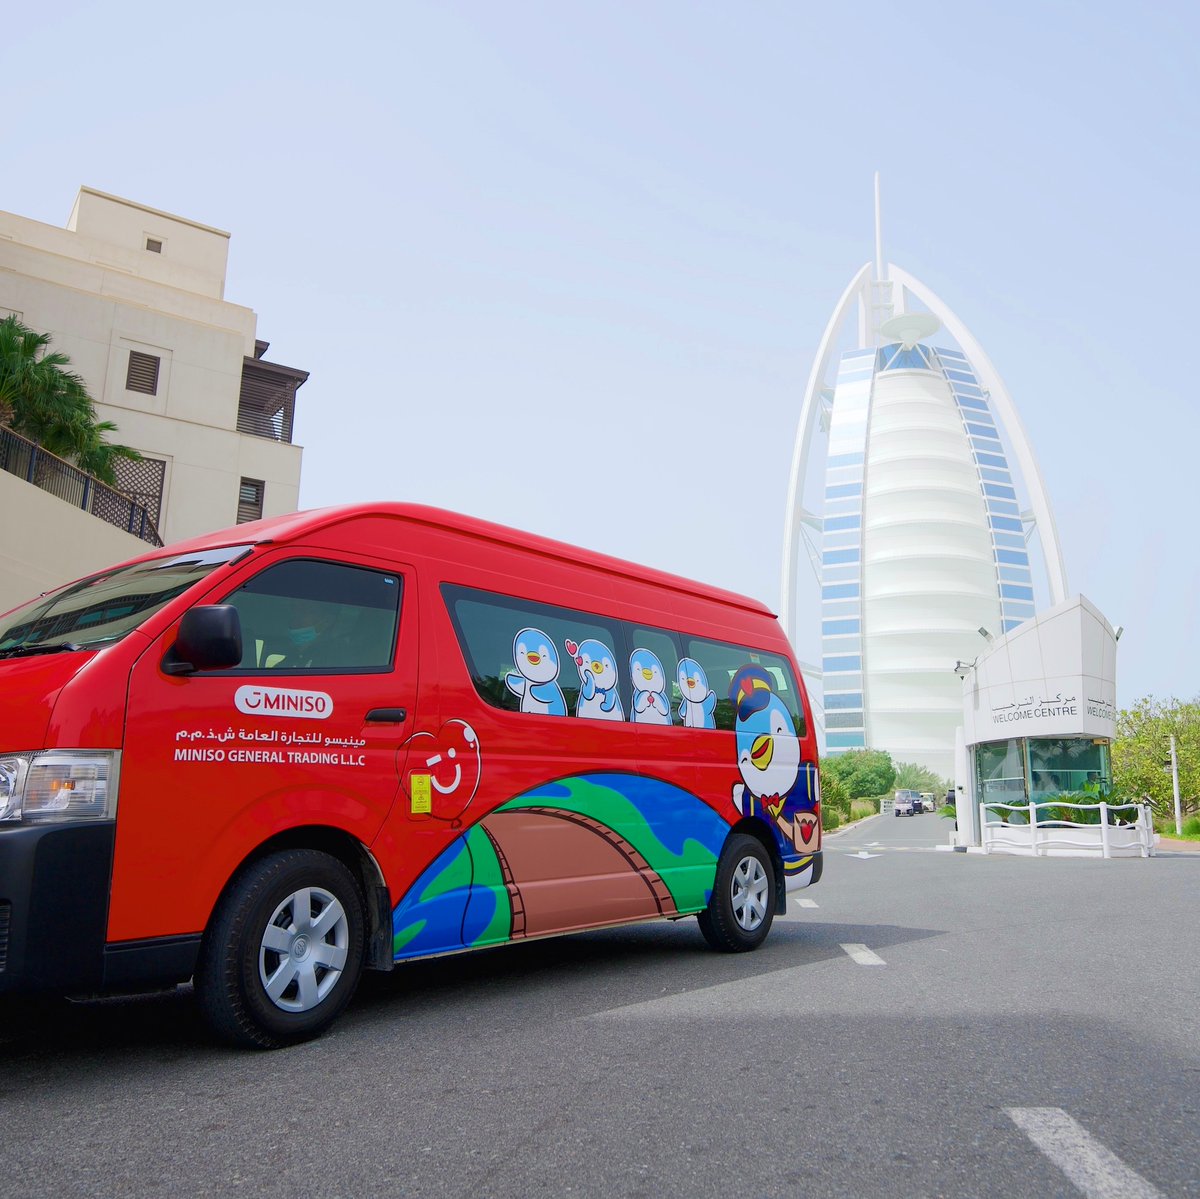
[730,666,820,852]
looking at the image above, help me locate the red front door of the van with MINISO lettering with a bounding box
[109,547,418,940]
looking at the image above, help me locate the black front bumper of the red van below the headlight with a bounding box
[0,821,116,994]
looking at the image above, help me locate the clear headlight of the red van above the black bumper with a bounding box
[0,749,120,823]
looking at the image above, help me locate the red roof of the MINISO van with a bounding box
[134,503,775,617]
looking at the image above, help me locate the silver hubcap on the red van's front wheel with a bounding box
[258,887,350,1012]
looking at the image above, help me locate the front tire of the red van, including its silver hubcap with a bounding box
[196,850,365,1049]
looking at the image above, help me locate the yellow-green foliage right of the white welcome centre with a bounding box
[1112,696,1200,816]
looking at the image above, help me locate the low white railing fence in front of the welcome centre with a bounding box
[979,799,1154,858]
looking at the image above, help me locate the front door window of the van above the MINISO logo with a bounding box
[224,559,401,673]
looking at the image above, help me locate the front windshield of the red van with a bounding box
[0,545,252,658]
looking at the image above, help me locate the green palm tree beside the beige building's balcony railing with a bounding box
[0,317,142,486]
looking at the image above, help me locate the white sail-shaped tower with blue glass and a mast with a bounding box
[781,178,1067,778]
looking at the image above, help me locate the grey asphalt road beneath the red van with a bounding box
[0,815,1200,1199]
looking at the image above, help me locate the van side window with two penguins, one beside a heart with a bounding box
[442,583,629,720]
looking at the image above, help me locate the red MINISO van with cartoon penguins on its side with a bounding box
[0,504,822,1047]
